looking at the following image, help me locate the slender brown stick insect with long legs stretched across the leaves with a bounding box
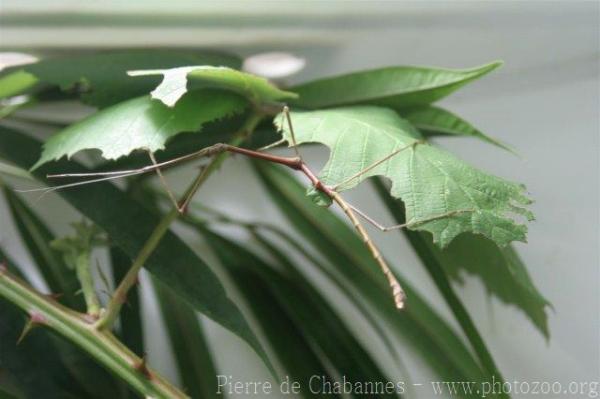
[21,106,469,309]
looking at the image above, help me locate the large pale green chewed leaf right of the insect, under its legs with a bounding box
[276,106,533,247]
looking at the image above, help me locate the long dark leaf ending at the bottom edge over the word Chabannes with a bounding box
[203,229,397,397]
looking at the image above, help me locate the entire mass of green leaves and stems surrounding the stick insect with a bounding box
[0,50,549,398]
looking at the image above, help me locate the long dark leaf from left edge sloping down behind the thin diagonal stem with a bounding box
[0,126,270,378]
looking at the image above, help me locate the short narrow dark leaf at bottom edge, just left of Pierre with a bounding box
[153,279,223,398]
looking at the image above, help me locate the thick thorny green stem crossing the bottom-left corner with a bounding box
[0,266,187,399]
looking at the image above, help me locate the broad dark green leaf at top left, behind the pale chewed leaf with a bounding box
[0,50,241,108]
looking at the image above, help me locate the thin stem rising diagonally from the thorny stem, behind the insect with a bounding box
[96,112,263,330]
